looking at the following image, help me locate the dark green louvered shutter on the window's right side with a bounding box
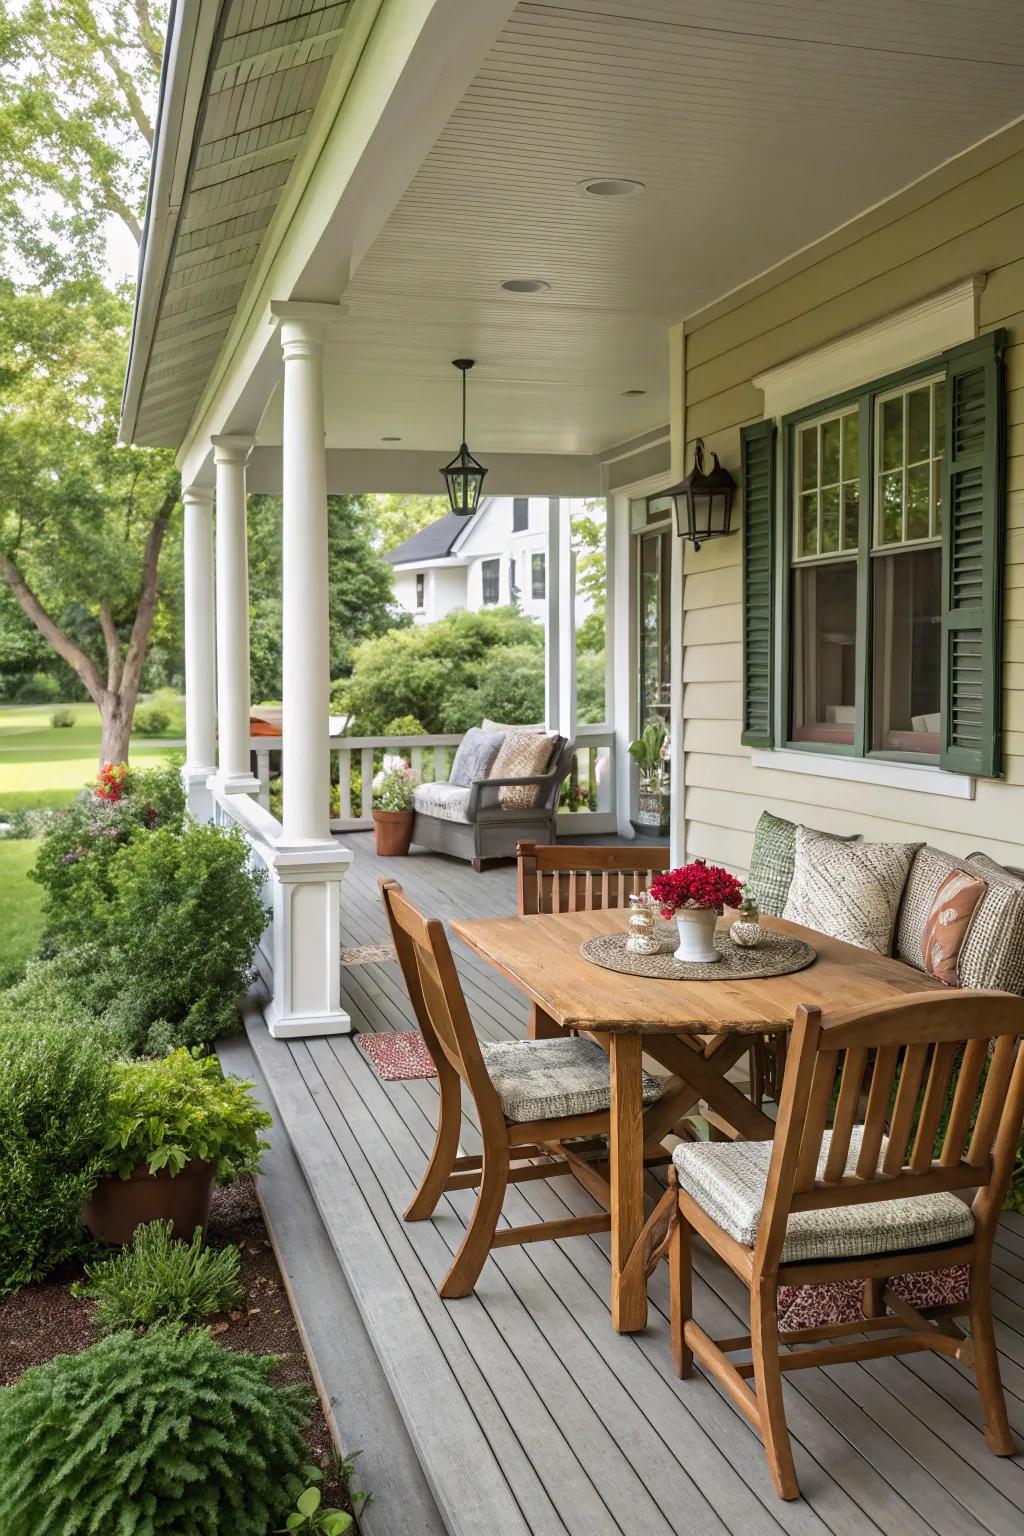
[940,330,1006,779]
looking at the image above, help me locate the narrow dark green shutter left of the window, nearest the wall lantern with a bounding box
[740,421,775,746]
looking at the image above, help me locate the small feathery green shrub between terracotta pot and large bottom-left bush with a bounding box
[72,1221,243,1333]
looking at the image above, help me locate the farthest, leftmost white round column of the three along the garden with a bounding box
[181,485,216,822]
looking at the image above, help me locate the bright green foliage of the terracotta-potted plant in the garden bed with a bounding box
[100,1051,272,1184]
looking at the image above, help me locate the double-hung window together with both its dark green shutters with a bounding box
[743,332,1004,774]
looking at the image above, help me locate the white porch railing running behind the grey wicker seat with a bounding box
[250,725,616,836]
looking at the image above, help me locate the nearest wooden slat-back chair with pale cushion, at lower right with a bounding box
[666,992,1024,1499]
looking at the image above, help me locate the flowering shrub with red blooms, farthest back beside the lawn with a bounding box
[32,762,184,946]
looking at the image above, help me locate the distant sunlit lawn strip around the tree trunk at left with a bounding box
[0,703,183,811]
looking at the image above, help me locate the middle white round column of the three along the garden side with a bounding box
[213,436,259,794]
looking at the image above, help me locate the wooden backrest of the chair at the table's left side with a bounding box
[379,880,497,1109]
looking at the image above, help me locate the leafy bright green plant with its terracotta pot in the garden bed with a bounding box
[81,1049,270,1244]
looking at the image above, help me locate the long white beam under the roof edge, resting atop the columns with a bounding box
[178,0,514,484]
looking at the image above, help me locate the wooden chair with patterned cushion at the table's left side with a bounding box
[381,880,662,1298]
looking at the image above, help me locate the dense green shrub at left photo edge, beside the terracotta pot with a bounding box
[0,1019,111,1296]
